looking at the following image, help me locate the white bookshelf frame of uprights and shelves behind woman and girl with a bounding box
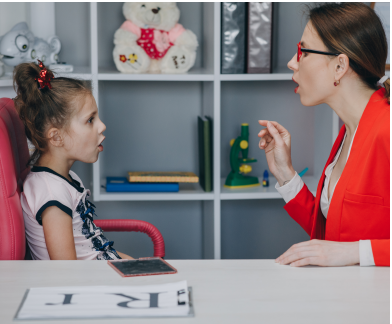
[90,3,338,259]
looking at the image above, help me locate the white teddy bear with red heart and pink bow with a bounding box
[113,2,199,73]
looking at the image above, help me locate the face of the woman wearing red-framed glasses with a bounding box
[287,22,337,106]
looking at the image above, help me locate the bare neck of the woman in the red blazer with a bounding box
[327,82,375,137]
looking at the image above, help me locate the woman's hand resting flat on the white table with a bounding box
[275,240,359,267]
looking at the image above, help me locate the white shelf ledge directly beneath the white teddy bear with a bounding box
[98,68,214,81]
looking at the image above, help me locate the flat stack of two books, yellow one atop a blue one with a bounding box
[106,172,199,192]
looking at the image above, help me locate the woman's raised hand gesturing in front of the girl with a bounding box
[258,120,295,186]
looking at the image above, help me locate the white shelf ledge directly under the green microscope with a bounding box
[220,176,319,200]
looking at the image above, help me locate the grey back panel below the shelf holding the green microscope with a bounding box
[222,199,309,259]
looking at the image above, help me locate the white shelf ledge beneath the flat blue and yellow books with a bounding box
[100,182,214,201]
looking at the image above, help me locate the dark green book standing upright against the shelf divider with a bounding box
[198,116,213,192]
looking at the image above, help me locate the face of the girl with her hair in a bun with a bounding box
[64,95,106,163]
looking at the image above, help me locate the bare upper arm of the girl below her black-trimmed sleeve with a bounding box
[42,206,77,260]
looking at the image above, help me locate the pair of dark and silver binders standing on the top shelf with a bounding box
[221,2,273,74]
